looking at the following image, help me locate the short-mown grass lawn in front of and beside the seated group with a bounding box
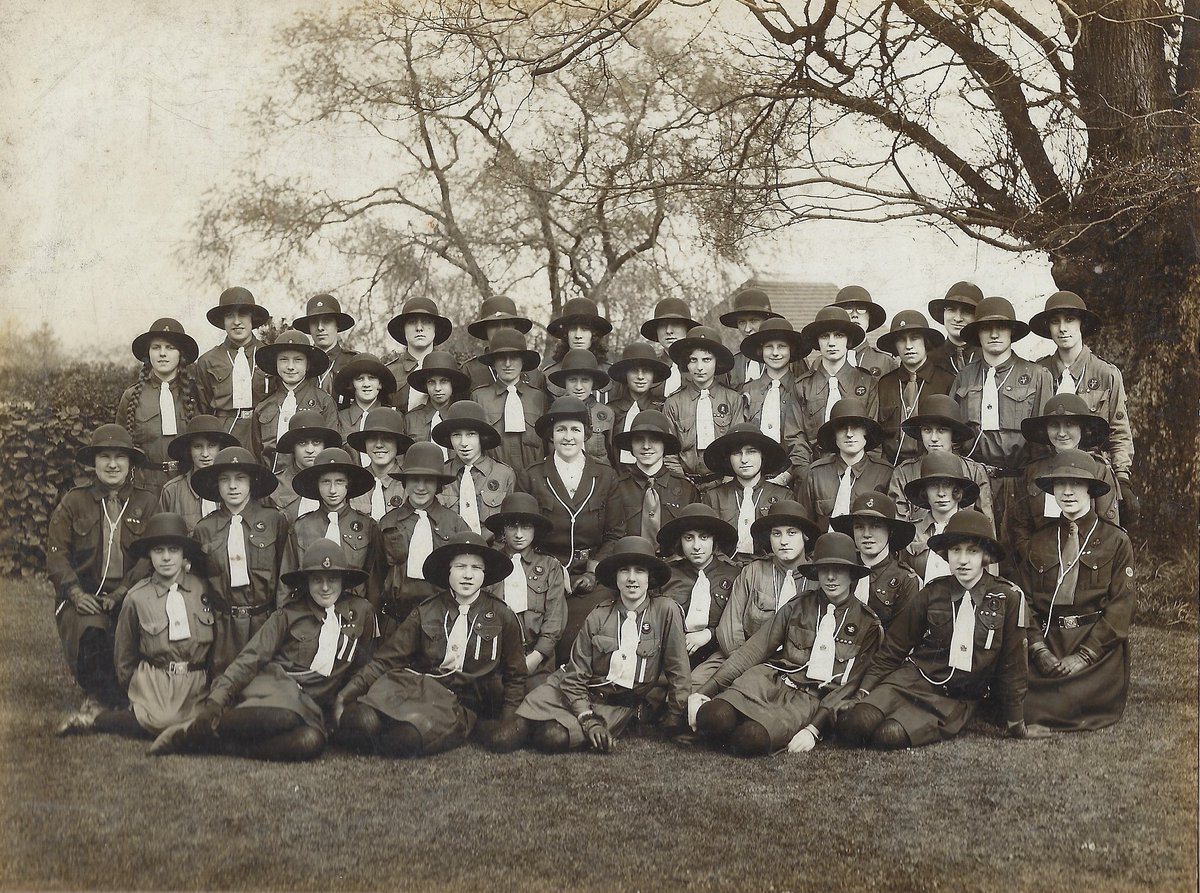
[0,581,1198,893]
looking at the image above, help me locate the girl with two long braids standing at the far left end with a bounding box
[116,318,199,498]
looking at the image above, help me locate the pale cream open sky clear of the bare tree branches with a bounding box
[0,0,1054,355]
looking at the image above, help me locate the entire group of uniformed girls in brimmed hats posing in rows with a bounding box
[46,282,1138,761]
